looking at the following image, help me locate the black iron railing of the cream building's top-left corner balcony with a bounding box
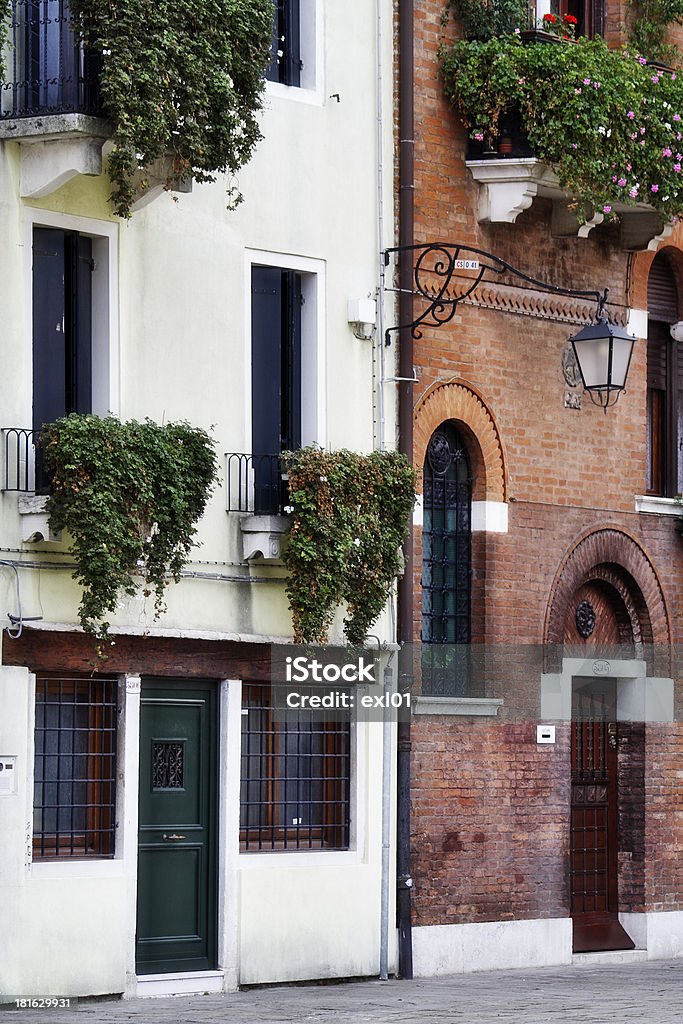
[0,0,102,120]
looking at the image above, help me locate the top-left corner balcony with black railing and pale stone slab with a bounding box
[0,0,108,198]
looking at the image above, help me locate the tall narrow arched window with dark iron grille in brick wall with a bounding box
[422,423,472,696]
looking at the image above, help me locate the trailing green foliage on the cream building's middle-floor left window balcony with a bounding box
[41,414,216,649]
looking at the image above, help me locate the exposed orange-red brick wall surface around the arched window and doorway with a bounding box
[412,0,683,925]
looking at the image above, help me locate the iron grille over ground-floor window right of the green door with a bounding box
[240,683,351,851]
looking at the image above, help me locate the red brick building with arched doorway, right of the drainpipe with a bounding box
[399,0,683,974]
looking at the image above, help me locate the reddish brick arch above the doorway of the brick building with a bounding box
[544,527,671,646]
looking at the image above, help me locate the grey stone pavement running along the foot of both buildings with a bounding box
[2,959,683,1024]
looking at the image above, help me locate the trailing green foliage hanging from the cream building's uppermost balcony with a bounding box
[70,0,273,217]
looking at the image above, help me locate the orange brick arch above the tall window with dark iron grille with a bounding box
[414,381,508,502]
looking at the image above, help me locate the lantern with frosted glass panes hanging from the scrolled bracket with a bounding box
[570,321,636,404]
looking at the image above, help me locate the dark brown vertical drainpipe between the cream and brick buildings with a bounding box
[396,0,415,978]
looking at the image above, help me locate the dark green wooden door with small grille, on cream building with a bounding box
[136,679,218,974]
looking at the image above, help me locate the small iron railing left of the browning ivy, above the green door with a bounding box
[225,452,289,515]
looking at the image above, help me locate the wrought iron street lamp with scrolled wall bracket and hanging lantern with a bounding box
[383,242,636,412]
